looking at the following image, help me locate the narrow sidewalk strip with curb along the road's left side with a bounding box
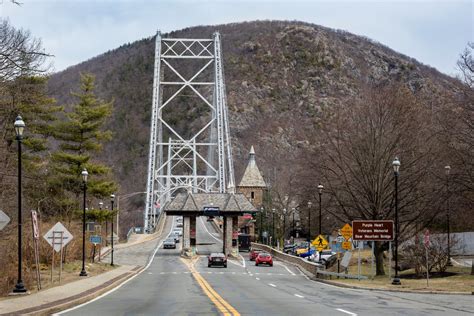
[0,266,144,315]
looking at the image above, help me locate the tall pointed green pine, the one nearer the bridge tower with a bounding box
[50,74,117,221]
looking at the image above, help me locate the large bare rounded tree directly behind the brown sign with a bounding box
[311,85,439,275]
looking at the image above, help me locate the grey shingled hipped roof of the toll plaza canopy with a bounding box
[163,193,258,216]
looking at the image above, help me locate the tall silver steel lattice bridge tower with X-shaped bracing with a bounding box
[144,32,235,232]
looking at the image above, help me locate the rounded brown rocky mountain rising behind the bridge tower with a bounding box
[49,21,458,226]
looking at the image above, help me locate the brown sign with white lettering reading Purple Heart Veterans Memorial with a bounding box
[352,220,394,241]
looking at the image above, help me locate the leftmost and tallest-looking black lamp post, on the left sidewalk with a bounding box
[13,115,27,293]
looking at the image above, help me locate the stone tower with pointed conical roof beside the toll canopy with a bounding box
[237,146,267,241]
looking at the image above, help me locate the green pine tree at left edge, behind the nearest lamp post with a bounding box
[0,76,62,215]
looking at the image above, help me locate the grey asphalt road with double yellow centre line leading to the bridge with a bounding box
[59,218,474,316]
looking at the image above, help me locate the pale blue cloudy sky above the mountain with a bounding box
[0,0,474,75]
